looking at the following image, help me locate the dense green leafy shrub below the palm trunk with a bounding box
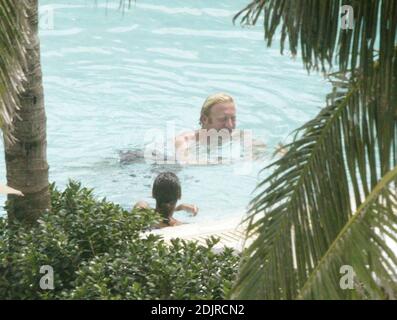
[0,182,239,299]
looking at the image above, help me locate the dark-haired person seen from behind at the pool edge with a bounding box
[134,172,198,229]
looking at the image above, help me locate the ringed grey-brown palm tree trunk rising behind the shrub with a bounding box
[4,0,50,224]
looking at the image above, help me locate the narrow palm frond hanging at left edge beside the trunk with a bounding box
[0,0,26,139]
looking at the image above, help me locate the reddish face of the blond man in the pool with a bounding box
[203,102,236,132]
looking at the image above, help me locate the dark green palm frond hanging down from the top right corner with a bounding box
[234,0,397,112]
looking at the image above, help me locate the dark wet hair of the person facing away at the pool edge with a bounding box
[152,172,182,204]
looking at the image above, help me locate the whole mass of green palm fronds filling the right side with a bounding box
[234,0,397,299]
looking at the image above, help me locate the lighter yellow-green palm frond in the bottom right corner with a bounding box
[299,167,397,299]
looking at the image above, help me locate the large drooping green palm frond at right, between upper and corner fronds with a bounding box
[235,63,397,299]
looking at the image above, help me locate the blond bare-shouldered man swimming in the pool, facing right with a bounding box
[175,92,265,163]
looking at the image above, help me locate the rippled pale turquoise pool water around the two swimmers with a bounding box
[0,0,330,221]
